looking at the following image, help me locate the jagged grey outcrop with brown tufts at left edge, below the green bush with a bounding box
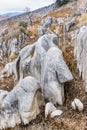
[0,30,29,59]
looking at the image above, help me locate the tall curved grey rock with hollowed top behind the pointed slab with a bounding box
[31,34,58,81]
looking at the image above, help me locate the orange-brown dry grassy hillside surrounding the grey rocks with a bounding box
[0,1,87,130]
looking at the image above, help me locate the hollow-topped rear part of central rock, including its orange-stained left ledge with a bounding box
[17,34,58,80]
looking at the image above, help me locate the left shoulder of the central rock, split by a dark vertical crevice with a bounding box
[1,45,35,80]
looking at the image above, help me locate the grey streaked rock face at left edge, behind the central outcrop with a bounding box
[0,31,29,57]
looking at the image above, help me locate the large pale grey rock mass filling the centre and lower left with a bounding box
[0,34,73,129]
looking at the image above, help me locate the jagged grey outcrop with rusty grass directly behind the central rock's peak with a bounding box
[38,17,76,37]
